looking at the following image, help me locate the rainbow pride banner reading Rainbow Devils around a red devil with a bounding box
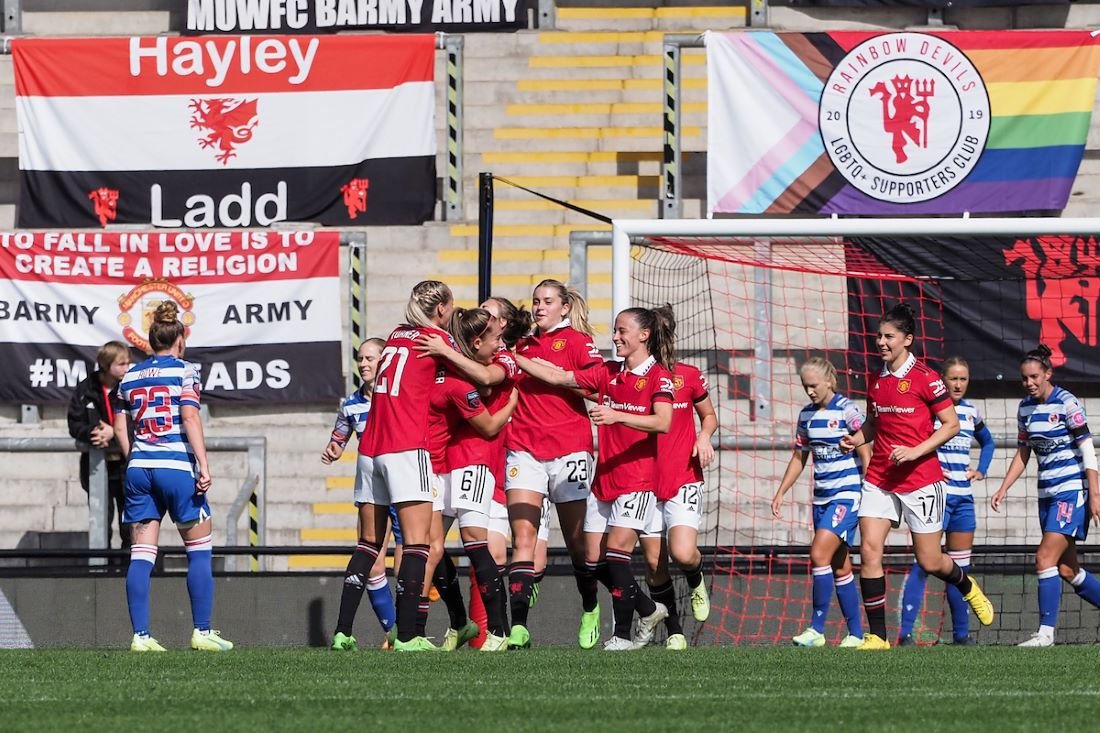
[706,31,1100,216]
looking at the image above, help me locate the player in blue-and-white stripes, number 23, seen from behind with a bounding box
[114,300,233,652]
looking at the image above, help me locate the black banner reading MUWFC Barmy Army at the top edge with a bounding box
[183,0,528,35]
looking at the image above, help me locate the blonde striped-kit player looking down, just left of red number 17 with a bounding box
[771,357,871,648]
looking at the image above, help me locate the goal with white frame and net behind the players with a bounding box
[613,219,1100,644]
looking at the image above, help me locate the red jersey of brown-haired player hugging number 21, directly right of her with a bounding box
[428,369,492,475]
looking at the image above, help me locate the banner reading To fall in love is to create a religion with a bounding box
[0,231,343,404]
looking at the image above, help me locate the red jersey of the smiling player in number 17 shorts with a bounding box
[867,354,952,494]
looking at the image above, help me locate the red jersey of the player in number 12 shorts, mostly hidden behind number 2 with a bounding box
[657,362,710,502]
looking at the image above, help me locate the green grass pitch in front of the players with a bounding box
[0,639,1100,733]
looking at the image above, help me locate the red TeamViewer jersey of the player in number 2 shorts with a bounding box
[574,358,672,502]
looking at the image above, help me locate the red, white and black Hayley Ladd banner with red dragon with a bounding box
[12,35,436,229]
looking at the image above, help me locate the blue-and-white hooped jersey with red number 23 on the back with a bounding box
[119,355,199,475]
